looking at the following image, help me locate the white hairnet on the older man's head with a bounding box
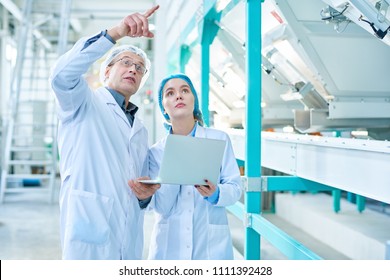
[99,45,151,89]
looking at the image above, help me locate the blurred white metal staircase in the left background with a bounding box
[0,0,61,203]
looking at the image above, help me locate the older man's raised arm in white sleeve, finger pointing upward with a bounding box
[50,5,159,118]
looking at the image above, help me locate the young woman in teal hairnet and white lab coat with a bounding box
[139,74,241,260]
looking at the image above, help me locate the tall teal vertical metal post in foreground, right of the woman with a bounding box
[245,0,261,260]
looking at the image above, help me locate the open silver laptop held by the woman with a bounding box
[139,134,226,185]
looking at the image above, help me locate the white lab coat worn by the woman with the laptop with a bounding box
[149,125,242,260]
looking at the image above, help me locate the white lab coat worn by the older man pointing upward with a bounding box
[50,34,148,259]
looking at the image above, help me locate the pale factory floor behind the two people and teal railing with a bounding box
[0,179,380,260]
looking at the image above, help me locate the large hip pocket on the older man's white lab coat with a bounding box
[67,190,113,245]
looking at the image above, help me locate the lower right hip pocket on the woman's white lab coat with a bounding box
[208,224,233,260]
